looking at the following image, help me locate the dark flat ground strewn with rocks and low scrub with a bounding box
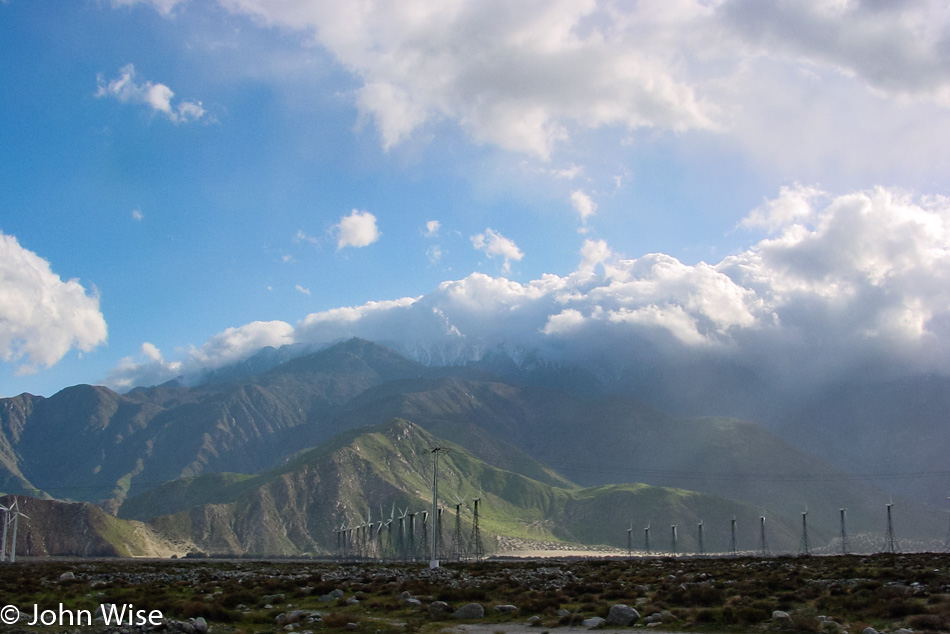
[0,554,950,634]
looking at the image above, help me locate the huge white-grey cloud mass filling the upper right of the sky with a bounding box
[122,0,950,187]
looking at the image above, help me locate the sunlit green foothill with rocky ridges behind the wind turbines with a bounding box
[121,419,797,555]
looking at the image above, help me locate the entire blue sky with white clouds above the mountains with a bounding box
[0,0,950,396]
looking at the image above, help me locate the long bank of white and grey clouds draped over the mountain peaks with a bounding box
[109,187,950,388]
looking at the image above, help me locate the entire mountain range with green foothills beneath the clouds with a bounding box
[0,339,945,555]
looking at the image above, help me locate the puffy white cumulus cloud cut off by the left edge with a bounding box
[0,233,107,374]
